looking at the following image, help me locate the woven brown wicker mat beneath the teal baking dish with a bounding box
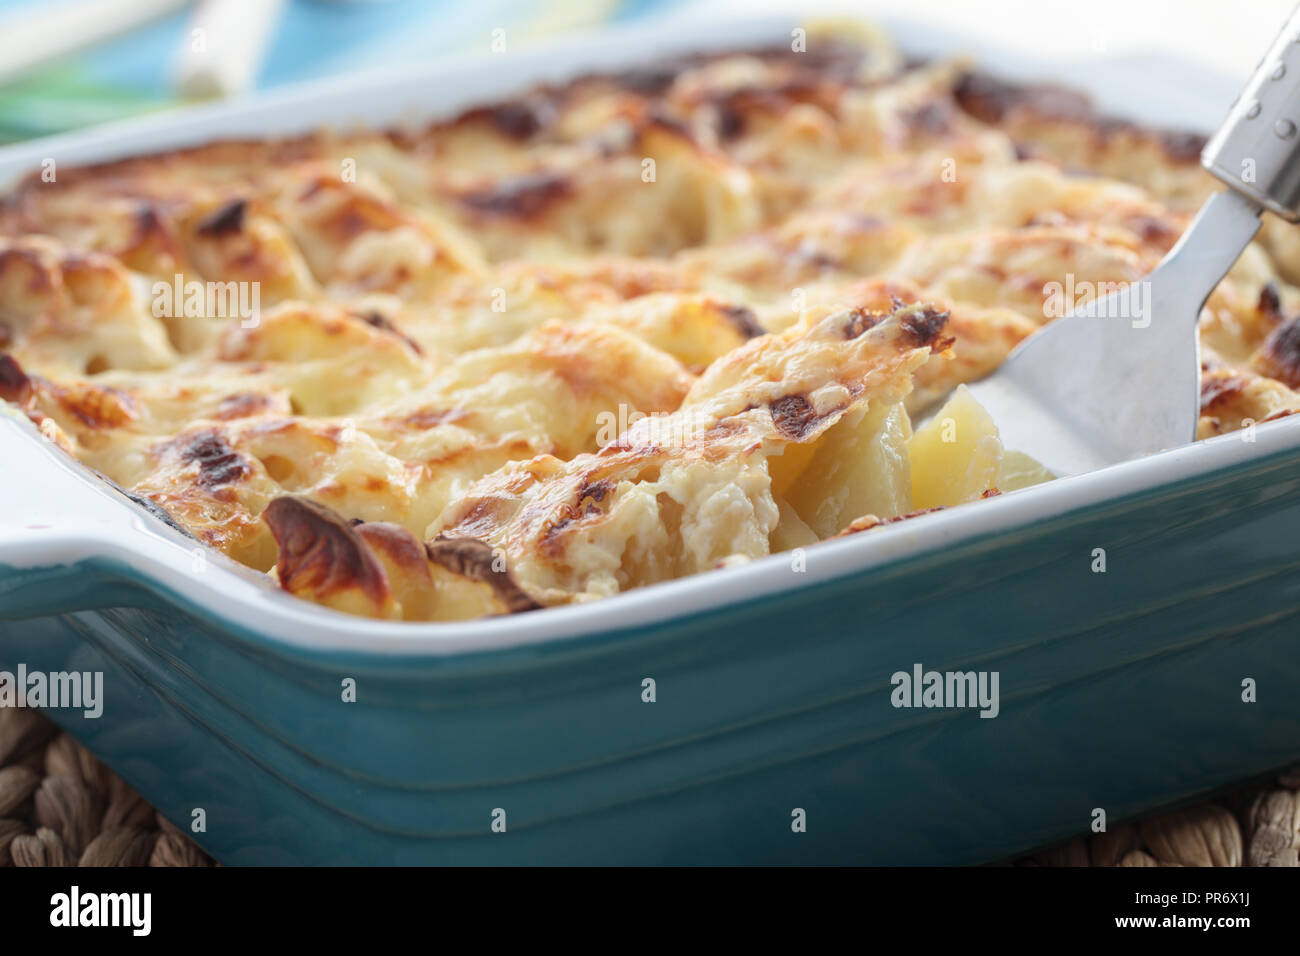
[0,708,1300,866]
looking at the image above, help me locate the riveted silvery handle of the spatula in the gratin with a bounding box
[1201,8,1300,222]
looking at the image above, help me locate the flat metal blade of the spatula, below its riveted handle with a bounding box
[970,191,1260,476]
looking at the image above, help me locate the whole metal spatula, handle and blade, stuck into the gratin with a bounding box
[946,8,1300,476]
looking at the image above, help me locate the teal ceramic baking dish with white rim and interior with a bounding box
[0,20,1300,864]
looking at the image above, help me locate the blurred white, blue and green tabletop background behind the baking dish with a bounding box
[0,0,1295,143]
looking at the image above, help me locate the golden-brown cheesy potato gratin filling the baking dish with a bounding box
[0,27,1300,620]
